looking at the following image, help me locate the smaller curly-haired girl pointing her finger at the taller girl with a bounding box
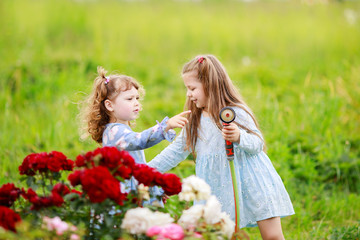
[83,67,190,205]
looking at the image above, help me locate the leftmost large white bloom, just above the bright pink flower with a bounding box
[121,208,152,234]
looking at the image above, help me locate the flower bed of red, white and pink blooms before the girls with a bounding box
[0,147,242,240]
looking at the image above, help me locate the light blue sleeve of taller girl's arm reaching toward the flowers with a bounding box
[148,130,190,172]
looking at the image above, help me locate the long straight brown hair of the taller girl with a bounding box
[182,55,265,154]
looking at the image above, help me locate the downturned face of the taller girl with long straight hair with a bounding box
[182,71,207,111]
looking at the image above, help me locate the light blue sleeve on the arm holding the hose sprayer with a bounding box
[234,108,264,154]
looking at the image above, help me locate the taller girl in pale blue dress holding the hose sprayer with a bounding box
[149,55,294,239]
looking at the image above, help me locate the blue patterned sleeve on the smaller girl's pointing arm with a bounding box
[103,117,176,151]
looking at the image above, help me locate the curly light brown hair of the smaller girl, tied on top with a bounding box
[80,67,145,143]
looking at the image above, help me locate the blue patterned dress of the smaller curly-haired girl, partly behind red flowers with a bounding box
[103,117,176,205]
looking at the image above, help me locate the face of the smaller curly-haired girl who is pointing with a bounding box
[105,87,141,124]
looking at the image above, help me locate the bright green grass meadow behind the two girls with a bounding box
[0,0,360,239]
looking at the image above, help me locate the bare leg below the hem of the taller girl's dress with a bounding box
[257,217,285,240]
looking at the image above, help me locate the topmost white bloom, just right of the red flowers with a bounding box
[179,175,211,202]
